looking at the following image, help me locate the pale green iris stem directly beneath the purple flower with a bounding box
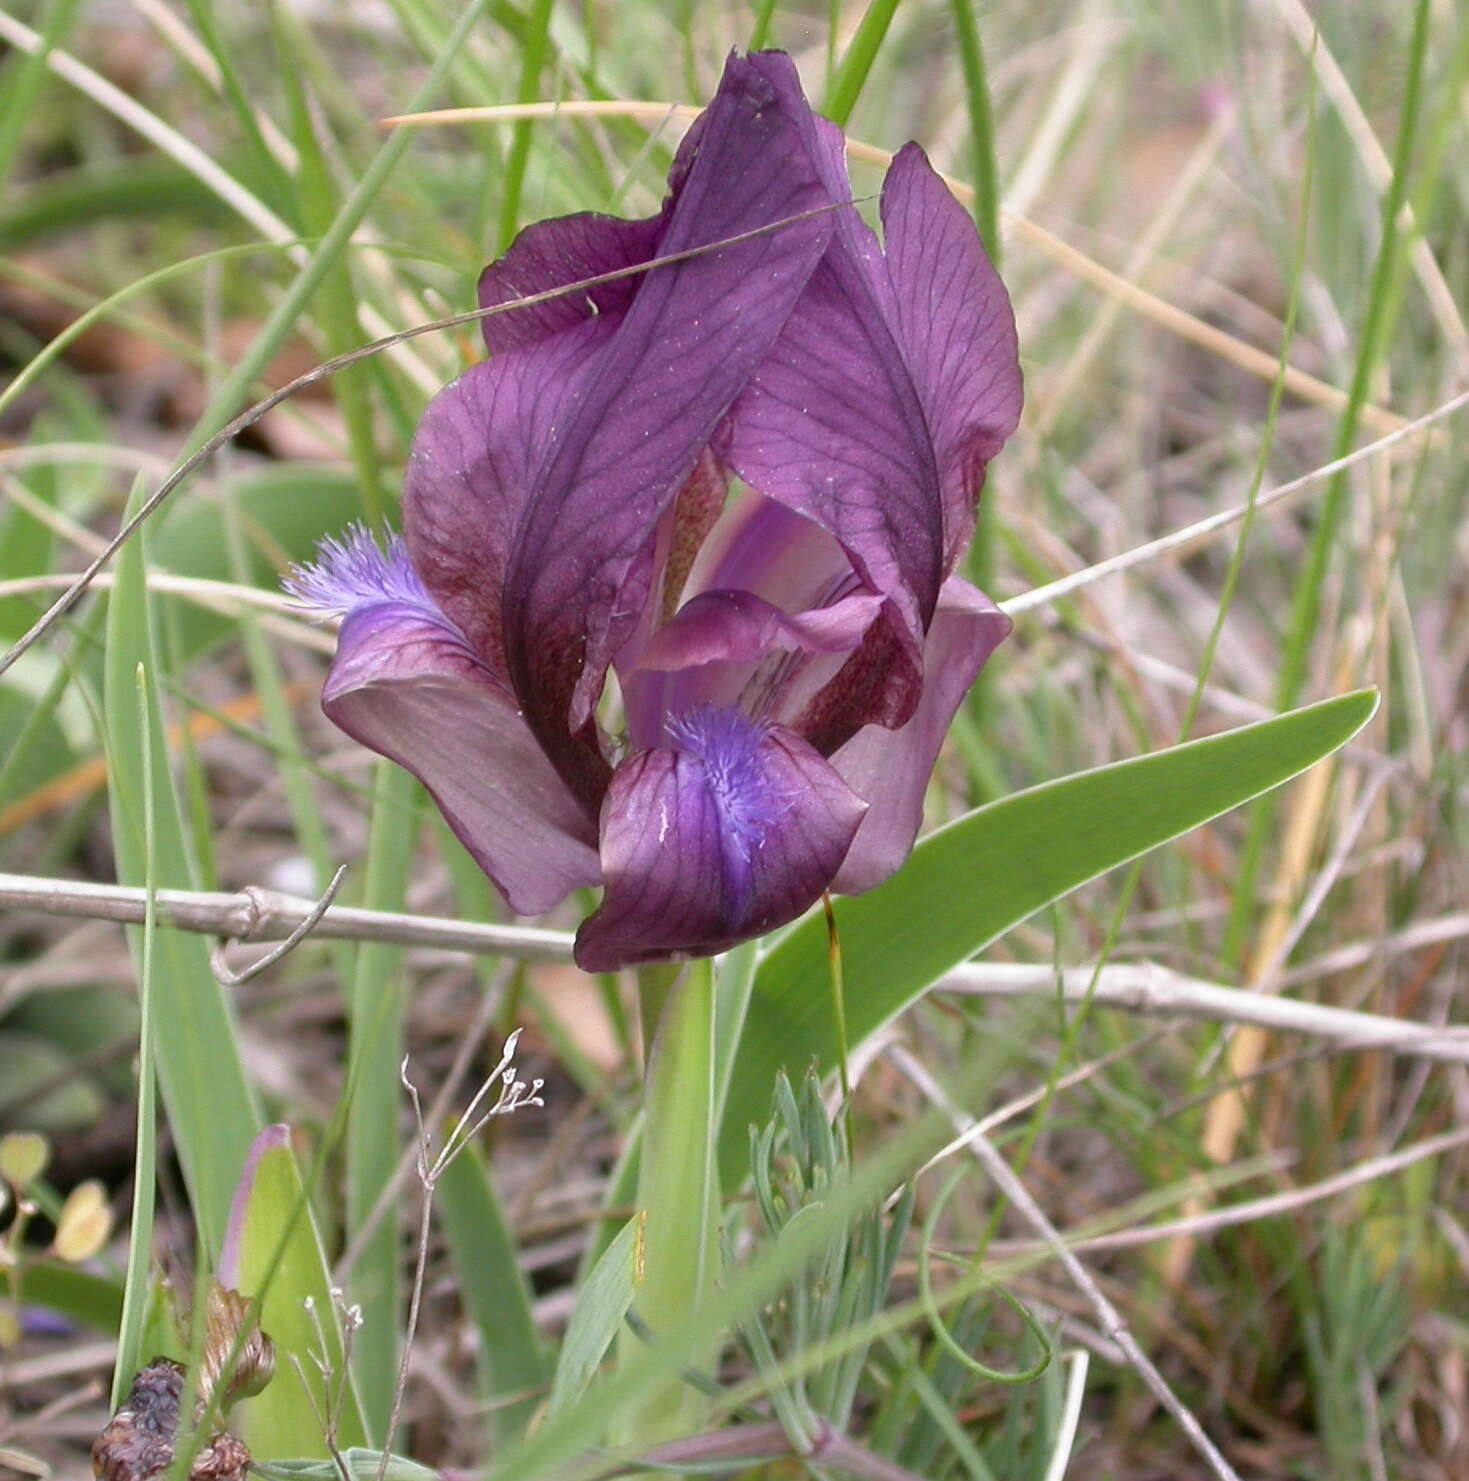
[615,960,720,1448]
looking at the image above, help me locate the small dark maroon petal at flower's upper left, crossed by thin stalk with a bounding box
[480,210,665,354]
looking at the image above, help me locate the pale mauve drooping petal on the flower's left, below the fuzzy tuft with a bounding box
[321,577,600,915]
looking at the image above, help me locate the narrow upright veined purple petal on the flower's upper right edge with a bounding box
[883,144,1023,569]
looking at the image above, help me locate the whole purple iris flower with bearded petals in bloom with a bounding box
[293,52,1020,970]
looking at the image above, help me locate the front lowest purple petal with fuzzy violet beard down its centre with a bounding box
[576,709,865,972]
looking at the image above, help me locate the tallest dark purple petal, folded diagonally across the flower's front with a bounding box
[505,58,831,798]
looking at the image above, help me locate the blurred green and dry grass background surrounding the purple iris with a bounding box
[0,0,1469,1481]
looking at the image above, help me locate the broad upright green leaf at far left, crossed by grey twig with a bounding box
[104,482,259,1248]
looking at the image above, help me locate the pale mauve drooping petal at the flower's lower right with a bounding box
[831,576,1011,895]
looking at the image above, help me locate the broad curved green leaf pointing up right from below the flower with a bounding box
[720,690,1377,1188]
